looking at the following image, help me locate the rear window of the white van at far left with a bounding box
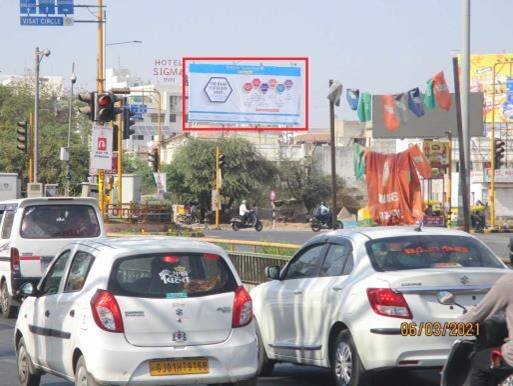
[20,204,101,239]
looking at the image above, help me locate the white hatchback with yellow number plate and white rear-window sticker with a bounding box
[15,237,258,386]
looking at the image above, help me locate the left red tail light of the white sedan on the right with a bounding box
[367,288,413,319]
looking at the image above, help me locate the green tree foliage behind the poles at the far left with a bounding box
[0,79,91,194]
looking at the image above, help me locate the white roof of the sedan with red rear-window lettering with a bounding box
[319,226,472,239]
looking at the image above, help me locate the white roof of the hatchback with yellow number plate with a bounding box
[76,236,225,258]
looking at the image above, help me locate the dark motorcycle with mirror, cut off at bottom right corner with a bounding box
[437,291,513,386]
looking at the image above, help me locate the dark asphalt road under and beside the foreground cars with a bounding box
[0,319,440,386]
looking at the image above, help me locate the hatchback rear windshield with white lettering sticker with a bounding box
[109,253,237,299]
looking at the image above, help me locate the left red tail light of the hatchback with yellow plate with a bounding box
[91,290,124,332]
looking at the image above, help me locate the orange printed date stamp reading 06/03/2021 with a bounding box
[401,322,480,337]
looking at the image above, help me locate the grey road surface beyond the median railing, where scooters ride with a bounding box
[204,229,513,257]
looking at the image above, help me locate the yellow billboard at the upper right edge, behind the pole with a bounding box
[470,54,513,123]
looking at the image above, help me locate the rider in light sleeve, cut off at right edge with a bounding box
[458,274,513,386]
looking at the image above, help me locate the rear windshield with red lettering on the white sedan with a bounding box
[367,235,504,271]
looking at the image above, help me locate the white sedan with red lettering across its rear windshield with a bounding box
[251,227,511,386]
